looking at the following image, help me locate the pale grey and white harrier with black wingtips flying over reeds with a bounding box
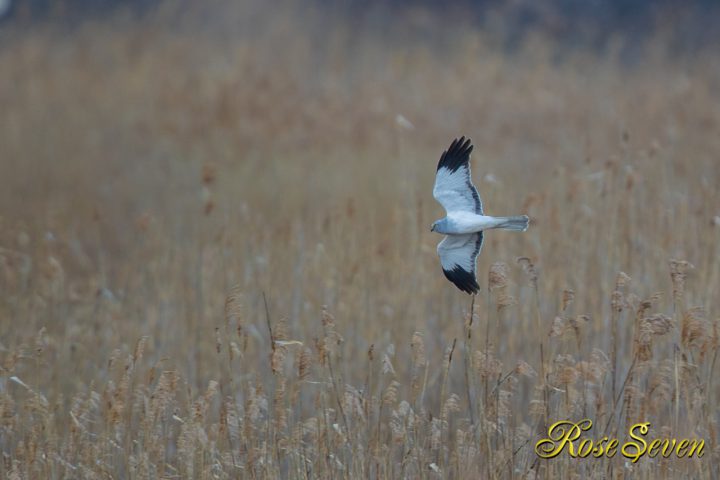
[430,137,528,295]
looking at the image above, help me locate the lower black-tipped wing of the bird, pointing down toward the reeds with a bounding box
[438,232,483,293]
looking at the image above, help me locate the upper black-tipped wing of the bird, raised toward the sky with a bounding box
[433,137,483,215]
